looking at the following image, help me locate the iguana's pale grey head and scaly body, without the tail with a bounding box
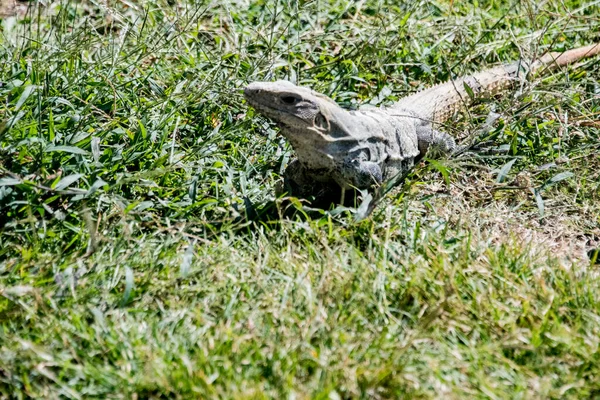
[244,81,440,202]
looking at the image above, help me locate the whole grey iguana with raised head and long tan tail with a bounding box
[244,43,600,204]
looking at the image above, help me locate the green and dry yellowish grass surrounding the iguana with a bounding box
[0,0,600,399]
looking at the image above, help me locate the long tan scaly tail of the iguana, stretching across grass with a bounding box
[390,43,600,123]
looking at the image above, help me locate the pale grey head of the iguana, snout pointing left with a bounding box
[244,81,341,134]
